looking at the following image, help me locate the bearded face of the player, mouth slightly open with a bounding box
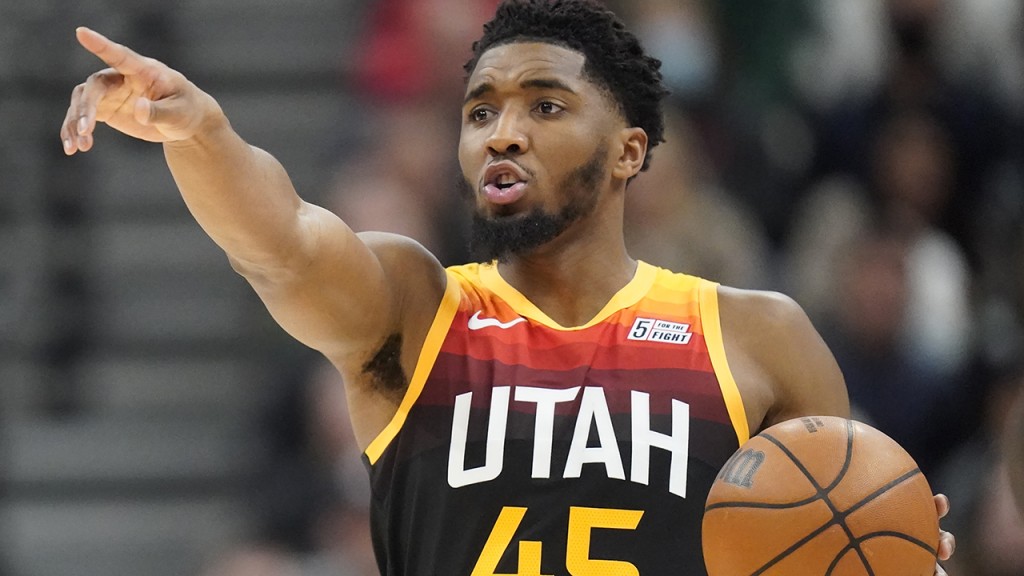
[459,42,625,259]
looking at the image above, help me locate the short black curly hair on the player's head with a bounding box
[465,0,669,170]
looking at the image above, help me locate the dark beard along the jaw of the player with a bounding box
[459,146,607,262]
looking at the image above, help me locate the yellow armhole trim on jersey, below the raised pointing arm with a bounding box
[366,273,461,465]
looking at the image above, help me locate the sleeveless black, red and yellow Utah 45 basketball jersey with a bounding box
[364,262,749,576]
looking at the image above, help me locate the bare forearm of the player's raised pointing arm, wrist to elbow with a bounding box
[164,117,306,270]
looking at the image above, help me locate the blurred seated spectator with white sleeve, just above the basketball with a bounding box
[786,103,978,469]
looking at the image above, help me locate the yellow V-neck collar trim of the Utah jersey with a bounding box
[479,261,657,331]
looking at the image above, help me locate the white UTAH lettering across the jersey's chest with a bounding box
[447,386,690,498]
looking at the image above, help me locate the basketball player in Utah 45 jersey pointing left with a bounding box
[60,0,953,576]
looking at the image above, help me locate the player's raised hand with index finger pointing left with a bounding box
[60,28,223,156]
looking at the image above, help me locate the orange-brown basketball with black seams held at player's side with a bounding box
[702,416,939,576]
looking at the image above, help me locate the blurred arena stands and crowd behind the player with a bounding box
[0,0,1024,576]
